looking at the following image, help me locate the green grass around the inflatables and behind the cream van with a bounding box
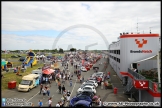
[1,54,64,91]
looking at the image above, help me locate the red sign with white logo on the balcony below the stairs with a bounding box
[133,80,149,90]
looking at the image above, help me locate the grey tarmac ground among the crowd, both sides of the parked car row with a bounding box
[2,58,129,106]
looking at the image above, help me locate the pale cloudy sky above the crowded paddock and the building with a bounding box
[1,1,161,50]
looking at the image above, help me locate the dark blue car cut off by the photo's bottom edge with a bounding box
[73,100,92,107]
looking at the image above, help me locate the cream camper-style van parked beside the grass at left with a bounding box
[18,74,39,92]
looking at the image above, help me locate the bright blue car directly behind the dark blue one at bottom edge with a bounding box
[69,94,92,107]
